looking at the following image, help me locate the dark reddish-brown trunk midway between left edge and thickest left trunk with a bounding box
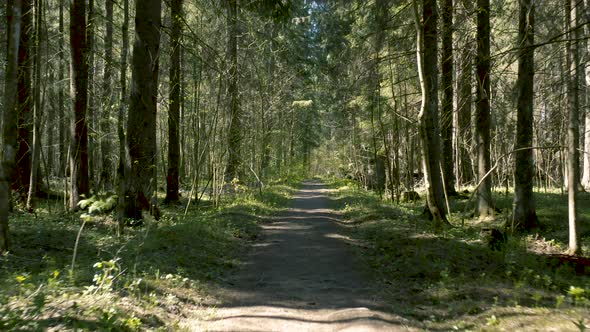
[69,0,89,209]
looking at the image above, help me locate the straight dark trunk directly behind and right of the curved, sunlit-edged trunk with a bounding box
[441,0,457,195]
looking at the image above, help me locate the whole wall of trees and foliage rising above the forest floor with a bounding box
[0,0,590,330]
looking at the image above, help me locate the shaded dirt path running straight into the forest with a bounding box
[189,181,409,331]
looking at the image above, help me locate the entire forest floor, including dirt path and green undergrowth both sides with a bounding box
[0,180,590,331]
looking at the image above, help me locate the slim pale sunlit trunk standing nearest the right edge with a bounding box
[565,0,581,254]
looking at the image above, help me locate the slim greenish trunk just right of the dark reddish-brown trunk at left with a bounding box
[99,0,114,188]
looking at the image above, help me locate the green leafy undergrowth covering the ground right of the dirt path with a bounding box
[332,181,590,331]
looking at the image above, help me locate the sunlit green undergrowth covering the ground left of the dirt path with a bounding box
[0,184,293,331]
